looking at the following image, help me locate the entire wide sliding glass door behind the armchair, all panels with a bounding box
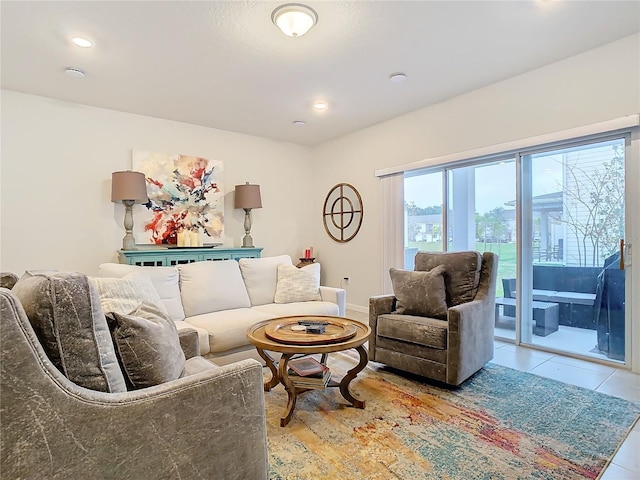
[403,136,630,362]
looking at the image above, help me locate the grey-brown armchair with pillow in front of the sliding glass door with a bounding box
[369,252,498,385]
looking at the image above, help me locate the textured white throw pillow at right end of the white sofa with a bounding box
[275,263,321,303]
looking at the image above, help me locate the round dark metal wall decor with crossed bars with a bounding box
[322,183,364,243]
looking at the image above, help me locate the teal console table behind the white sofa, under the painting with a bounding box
[118,247,262,267]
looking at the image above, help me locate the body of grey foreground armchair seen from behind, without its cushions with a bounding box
[0,288,267,480]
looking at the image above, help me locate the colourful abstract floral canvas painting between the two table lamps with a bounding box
[132,150,224,245]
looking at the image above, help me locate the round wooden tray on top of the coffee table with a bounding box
[264,316,358,345]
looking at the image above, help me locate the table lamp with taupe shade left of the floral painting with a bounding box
[111,170,149,250]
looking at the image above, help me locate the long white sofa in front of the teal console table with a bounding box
[98,255,346,365]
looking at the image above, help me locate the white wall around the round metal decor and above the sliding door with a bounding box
[313,35,640,312]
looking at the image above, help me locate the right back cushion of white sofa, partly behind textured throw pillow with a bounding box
[238,255,292,306]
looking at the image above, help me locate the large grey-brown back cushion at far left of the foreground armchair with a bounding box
[13,272,127,393]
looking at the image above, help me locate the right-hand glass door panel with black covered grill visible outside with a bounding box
[511,138,625,361]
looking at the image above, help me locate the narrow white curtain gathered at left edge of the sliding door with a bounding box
[380,172,404,293]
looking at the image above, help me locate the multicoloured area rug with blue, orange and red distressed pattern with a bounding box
[265,353,640,480]
